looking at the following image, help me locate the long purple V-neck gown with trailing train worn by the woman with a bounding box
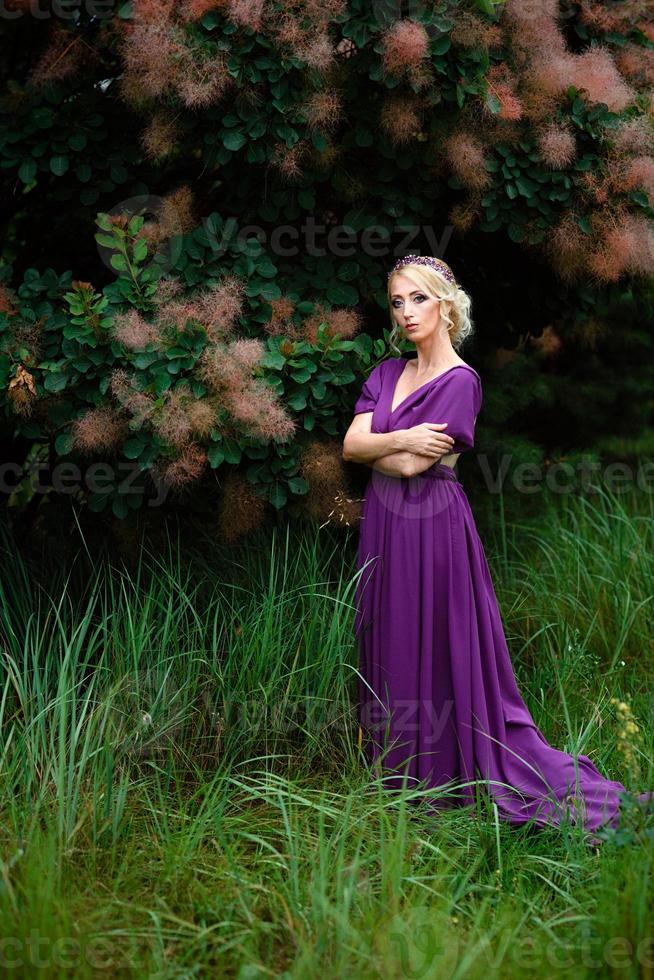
[354,358,640,830]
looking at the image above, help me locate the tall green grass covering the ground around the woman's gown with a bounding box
[0,478,654,980]
